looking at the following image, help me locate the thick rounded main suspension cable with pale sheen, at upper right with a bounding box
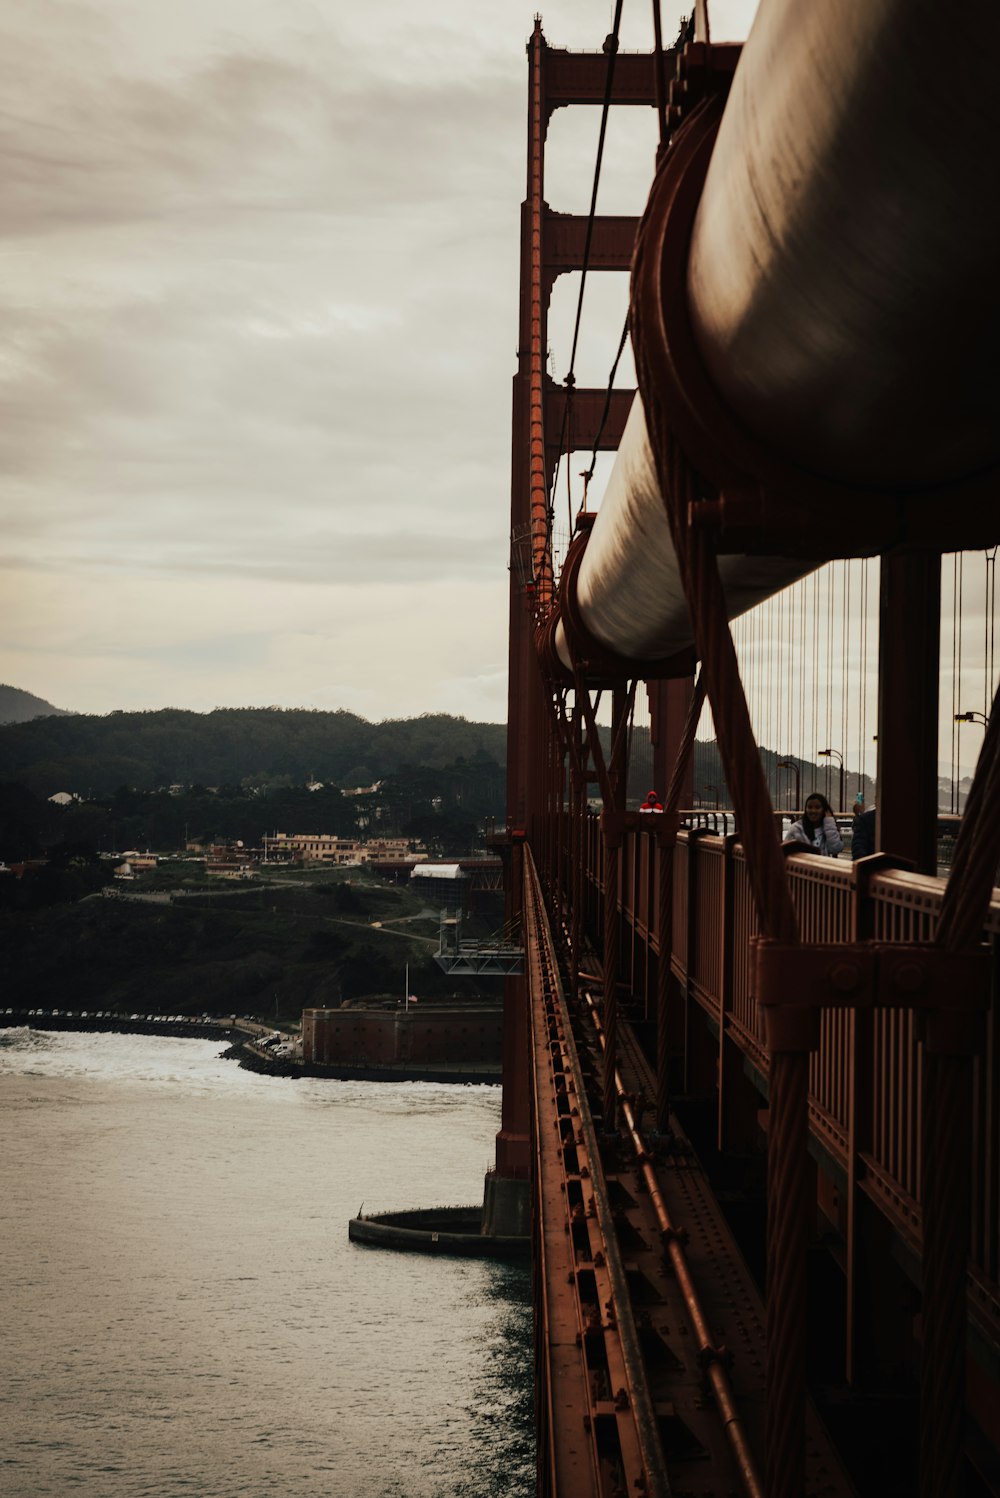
[554,0,1000,668]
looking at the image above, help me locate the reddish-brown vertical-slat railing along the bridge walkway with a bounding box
[585,818,1000,1338]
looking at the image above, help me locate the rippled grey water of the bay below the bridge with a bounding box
[0,1029,534,1498]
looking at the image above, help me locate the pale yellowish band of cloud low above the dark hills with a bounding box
[0,571,506,722]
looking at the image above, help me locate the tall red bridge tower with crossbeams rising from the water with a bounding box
[485,18,654,1231]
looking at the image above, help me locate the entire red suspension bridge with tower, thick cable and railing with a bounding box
[496,0,1000,1498]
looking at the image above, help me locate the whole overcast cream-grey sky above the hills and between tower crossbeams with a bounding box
[0,0,754,721]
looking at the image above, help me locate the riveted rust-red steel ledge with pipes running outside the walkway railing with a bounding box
[525,850,853,1498]
